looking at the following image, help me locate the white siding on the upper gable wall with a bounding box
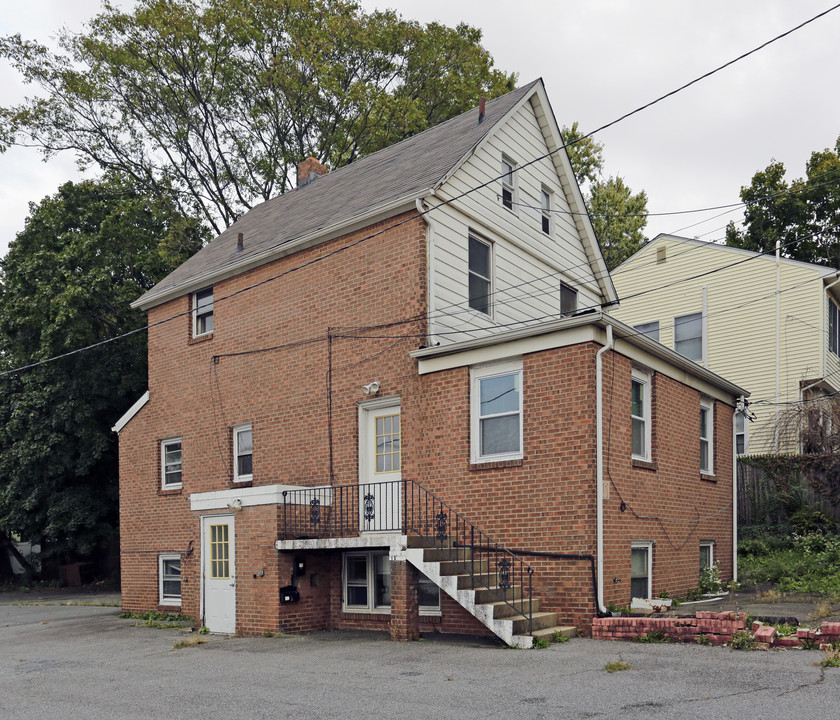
[430,103,602,344]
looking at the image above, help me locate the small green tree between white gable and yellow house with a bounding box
[561,121,647,270]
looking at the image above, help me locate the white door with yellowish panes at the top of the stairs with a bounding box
[359,401,402,532]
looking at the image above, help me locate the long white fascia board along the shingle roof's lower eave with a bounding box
[137,195,431,310]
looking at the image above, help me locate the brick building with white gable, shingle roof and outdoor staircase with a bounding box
[115,81,744,645]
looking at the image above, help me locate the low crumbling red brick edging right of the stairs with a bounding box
[592,612,747,645]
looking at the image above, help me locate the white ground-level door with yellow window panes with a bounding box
[201,515,236,635]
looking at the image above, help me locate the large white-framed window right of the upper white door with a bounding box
[470,361,522,462]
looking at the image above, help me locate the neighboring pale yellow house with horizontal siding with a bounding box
[611,235,840,454]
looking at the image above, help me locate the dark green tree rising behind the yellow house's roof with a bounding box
[726,138,840,267]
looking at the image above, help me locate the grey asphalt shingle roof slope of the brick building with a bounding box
[134,80,540,308]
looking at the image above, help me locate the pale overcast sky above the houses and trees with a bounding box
[0,0,840,254]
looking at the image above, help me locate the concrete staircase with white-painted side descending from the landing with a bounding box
[405,535,577,648]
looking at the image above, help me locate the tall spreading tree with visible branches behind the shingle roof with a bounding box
[0,0,516,232]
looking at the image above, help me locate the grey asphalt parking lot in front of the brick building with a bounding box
[0,598,840,720]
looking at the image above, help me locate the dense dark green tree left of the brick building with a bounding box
[0,177,207,556]
